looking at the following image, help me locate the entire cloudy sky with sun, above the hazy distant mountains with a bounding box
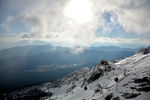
[0,0,150,51]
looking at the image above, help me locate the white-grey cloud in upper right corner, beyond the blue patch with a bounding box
[94,0,150,34]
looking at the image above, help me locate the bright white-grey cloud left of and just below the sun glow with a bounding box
[17,0,96,46]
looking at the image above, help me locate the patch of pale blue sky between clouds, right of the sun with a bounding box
[95,12,147,38]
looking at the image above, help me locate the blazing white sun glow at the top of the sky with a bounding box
[65,0,92,23]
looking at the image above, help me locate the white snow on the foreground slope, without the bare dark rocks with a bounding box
[45,53,150,100]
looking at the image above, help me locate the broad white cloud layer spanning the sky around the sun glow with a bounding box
[1,0,150,48]
